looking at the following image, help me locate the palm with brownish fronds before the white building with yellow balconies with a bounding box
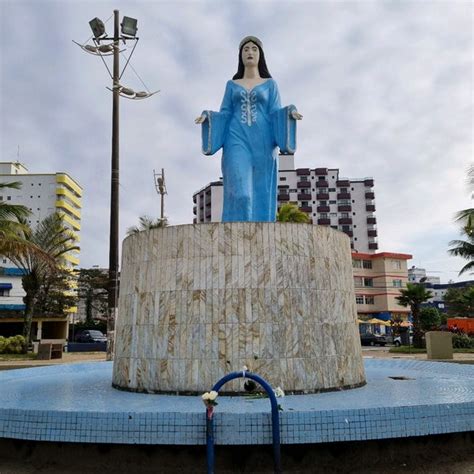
[7,213,79,352]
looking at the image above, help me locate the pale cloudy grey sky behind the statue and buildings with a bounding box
[0,0,474,282]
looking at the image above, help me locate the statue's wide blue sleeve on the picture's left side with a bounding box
[201,81,232,155]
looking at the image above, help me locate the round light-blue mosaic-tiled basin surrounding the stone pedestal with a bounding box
[0,359,474,445]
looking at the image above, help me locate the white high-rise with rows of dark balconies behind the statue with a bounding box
[193,155,378,253]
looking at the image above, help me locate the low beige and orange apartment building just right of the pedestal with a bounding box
[352,252,412,321]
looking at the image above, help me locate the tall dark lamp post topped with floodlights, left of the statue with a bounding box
[74,10,159,360]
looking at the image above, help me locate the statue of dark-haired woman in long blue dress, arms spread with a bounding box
[195,36,302,222]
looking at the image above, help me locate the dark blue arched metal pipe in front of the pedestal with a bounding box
[206,371,282,474]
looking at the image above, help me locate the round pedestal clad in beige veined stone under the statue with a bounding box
[113,223,365,393]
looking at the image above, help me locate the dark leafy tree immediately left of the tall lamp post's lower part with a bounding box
[77,268,109,326]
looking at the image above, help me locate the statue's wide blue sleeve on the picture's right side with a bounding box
[270,82,296,155]
